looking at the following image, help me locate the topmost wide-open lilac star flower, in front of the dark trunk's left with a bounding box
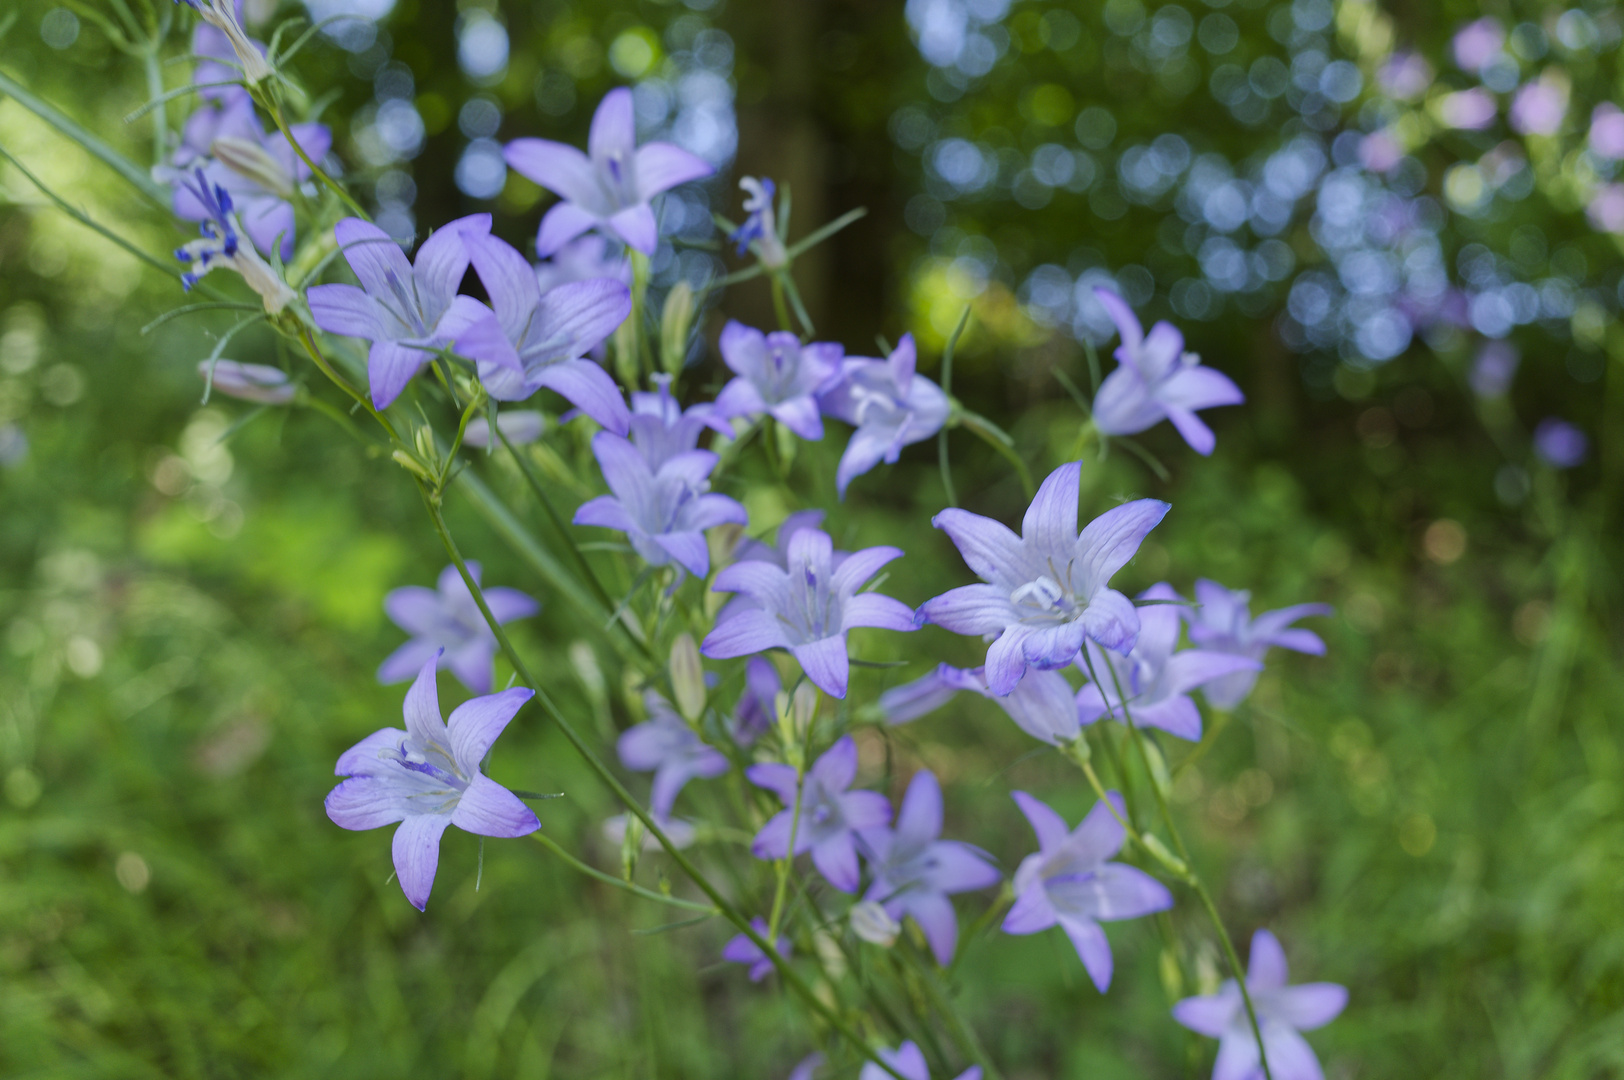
[503,86,715,258]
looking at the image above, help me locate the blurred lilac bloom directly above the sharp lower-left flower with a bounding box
[378,560,541,693]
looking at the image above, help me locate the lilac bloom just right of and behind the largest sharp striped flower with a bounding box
[1077,585,1263,741]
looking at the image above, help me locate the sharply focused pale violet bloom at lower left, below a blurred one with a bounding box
[326,656,541,911]
